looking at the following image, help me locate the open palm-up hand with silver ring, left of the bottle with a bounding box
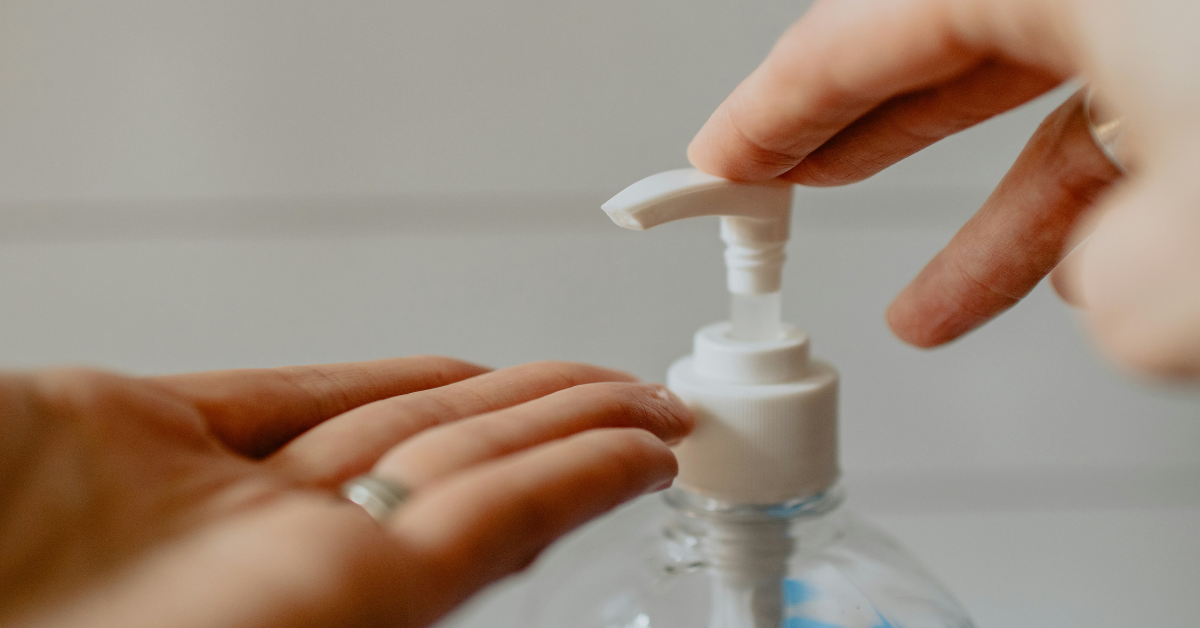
[0,358,692,628]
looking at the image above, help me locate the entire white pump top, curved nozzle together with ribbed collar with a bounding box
[604,169,838,504]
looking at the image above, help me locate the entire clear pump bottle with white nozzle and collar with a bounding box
[527,169,972,628]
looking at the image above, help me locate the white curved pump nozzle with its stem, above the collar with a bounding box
[601,168,792,340]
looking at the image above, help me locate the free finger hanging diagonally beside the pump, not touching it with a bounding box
[887,94,1121,347]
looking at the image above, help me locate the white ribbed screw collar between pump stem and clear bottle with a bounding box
[667,323,838,504]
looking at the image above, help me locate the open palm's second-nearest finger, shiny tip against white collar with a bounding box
[373,383,695,489]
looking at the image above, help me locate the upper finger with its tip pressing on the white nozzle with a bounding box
[688,0,1073,180]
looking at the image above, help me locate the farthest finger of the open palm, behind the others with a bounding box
[146,355,487,457]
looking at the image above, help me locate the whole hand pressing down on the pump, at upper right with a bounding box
[689,0,1200,377]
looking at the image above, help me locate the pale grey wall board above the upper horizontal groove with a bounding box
[0,0,1060,202]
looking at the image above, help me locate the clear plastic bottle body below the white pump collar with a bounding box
[526,486,972,628]
